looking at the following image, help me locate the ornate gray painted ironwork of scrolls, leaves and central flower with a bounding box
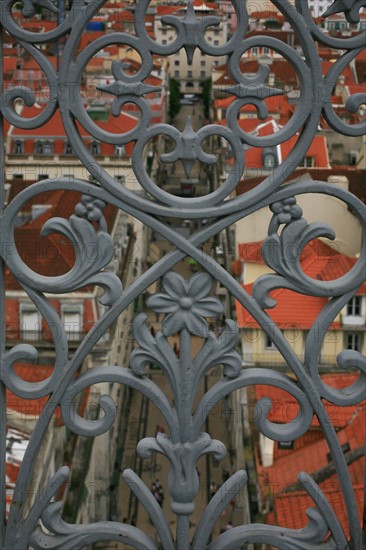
[0,0,366,550]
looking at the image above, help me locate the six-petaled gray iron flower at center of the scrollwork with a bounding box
[147,271,224,336]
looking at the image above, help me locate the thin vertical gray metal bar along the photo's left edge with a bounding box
[0,18,6,547]
